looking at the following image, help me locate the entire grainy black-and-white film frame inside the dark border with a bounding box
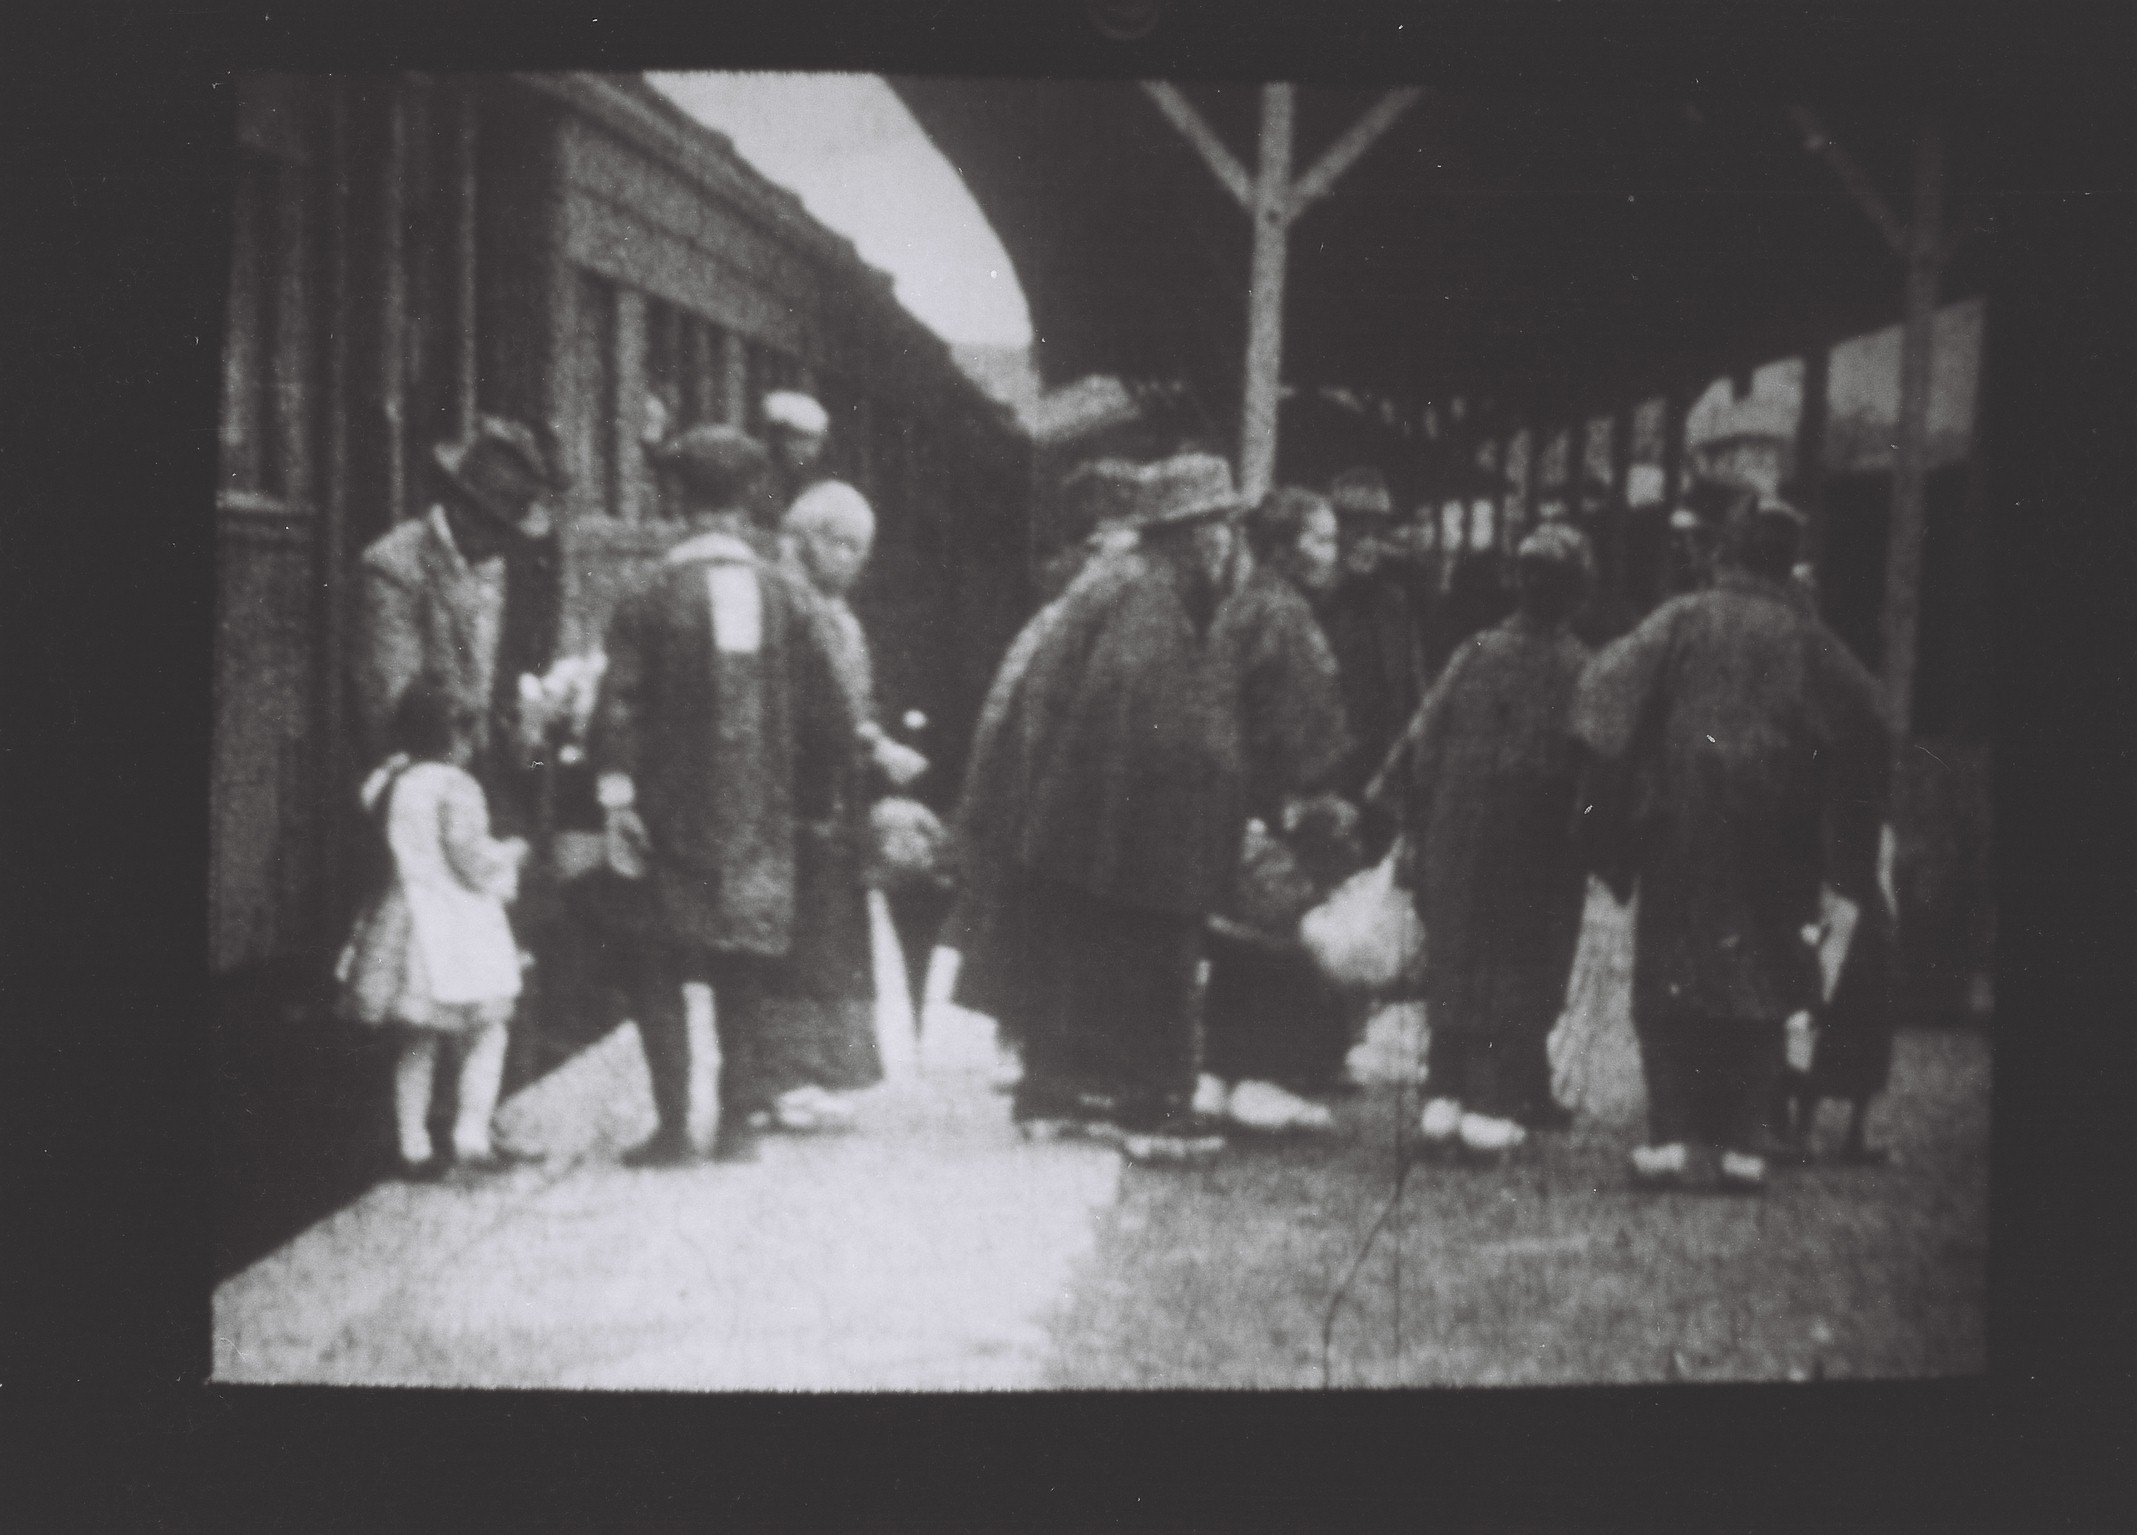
[192,53,2026,1392]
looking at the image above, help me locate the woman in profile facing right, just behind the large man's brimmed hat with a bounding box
[1197,487,1355,1131]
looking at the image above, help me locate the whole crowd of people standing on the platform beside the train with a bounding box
[340,393,1893,1191]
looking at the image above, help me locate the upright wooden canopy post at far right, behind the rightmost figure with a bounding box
[1883,122,1945,744]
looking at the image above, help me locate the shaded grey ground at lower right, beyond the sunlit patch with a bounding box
[1047,889,1990,1387]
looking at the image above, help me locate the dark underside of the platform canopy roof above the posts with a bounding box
[891,58,2107,431]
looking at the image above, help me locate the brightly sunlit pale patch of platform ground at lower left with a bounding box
[214,906,1120,1390]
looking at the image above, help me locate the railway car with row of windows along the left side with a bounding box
[209,75,1030,1261]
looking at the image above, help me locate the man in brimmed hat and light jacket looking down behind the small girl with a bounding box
[355,417,564,832]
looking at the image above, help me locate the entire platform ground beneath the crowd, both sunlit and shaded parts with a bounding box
[214,889,1987,1390]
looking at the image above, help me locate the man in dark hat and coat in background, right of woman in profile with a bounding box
[1319,468,1425,857]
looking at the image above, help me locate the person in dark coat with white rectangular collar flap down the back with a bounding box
[592,425,859,1165]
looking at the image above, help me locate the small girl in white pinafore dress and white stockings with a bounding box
[340,680,528,1180]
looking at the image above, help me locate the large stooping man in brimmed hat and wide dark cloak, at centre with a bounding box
[962,455,1239,1159]
